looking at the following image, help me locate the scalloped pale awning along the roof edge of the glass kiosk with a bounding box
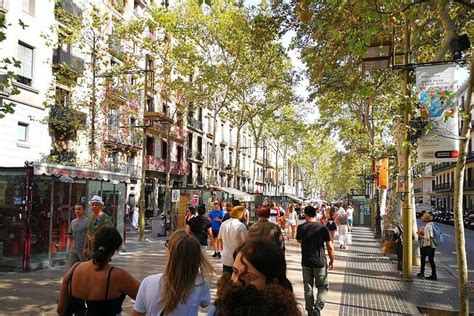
[33,163,130,183]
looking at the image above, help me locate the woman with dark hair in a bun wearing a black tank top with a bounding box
[57,225,140,316]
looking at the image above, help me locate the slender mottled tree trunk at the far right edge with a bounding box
[454,51,474,315]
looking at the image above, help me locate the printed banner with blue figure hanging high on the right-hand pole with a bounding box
[416,65,459,162]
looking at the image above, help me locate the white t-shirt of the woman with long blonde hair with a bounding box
[133,273,211,316]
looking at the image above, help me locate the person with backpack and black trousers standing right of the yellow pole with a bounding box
[416,212,438,281]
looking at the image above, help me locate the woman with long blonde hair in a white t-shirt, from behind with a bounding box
[132,230,215,316]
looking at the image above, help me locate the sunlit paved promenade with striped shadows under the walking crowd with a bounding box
[0,227,474,315]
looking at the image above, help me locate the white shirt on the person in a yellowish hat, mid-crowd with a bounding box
[219,218,247,267]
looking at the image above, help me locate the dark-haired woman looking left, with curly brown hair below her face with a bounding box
[208,238,301,316]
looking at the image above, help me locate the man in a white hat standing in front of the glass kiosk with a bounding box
[84,195,112,259]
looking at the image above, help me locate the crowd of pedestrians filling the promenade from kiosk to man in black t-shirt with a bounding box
[58,196,353,315]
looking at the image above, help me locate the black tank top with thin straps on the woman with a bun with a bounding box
[69,266,126,316]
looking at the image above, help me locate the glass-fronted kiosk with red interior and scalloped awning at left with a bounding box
[0,163,130,271]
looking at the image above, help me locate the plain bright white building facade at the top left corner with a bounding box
[0,1,54,167]
